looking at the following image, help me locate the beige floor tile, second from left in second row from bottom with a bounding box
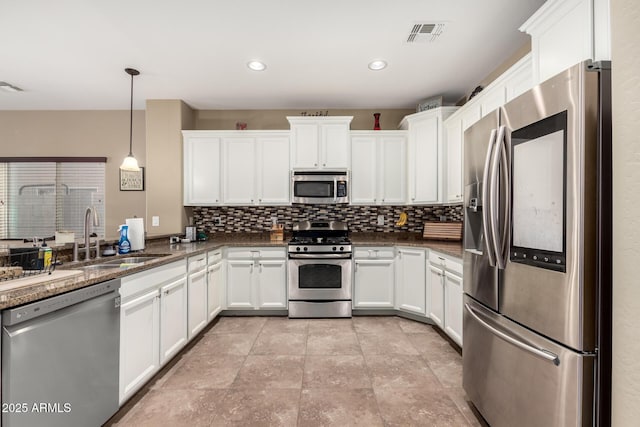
[232,355,304,390]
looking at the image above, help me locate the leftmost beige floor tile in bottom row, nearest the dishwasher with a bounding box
[118,390,226,427]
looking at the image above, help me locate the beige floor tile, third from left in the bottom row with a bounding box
[298,389,384,427]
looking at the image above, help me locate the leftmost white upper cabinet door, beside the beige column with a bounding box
[183,132,221,206]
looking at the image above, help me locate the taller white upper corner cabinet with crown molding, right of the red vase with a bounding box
[400,107,458,204]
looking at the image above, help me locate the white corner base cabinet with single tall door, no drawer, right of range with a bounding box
[396,248,427,315]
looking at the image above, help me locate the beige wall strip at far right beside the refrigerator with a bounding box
[611,0,640,427]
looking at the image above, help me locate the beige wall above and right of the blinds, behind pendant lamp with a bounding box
[0,110,145,239]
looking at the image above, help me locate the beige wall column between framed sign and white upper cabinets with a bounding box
[145,99,195,236]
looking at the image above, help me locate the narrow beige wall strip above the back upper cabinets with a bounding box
[195,109,416,130]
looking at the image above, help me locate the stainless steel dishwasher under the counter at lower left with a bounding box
[2,279,120,427]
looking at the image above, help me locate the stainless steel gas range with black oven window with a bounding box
[288,221,352,317]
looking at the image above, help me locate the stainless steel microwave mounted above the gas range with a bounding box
[291,171,349,204]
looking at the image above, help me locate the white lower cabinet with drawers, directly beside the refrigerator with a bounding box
[428,251,462,346]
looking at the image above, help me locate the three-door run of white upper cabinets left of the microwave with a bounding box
[183,131,290,206]
